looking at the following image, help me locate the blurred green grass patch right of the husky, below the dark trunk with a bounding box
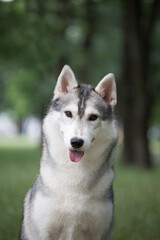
[113,166,160,240]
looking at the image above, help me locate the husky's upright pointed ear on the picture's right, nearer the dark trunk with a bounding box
[95,73,117,108]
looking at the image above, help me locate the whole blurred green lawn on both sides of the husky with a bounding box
[0,137,160,240]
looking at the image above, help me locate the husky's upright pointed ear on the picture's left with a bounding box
[54,65,78,98]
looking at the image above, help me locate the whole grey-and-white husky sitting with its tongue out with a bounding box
[19,65,117,240]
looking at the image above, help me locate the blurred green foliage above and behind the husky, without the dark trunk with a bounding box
[0,0,160,123]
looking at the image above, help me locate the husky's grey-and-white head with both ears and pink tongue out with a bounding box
[43,65,117,162]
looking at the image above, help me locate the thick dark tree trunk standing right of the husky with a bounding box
[122,0,157,168]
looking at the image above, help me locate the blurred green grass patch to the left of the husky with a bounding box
[0,141,40,240]
